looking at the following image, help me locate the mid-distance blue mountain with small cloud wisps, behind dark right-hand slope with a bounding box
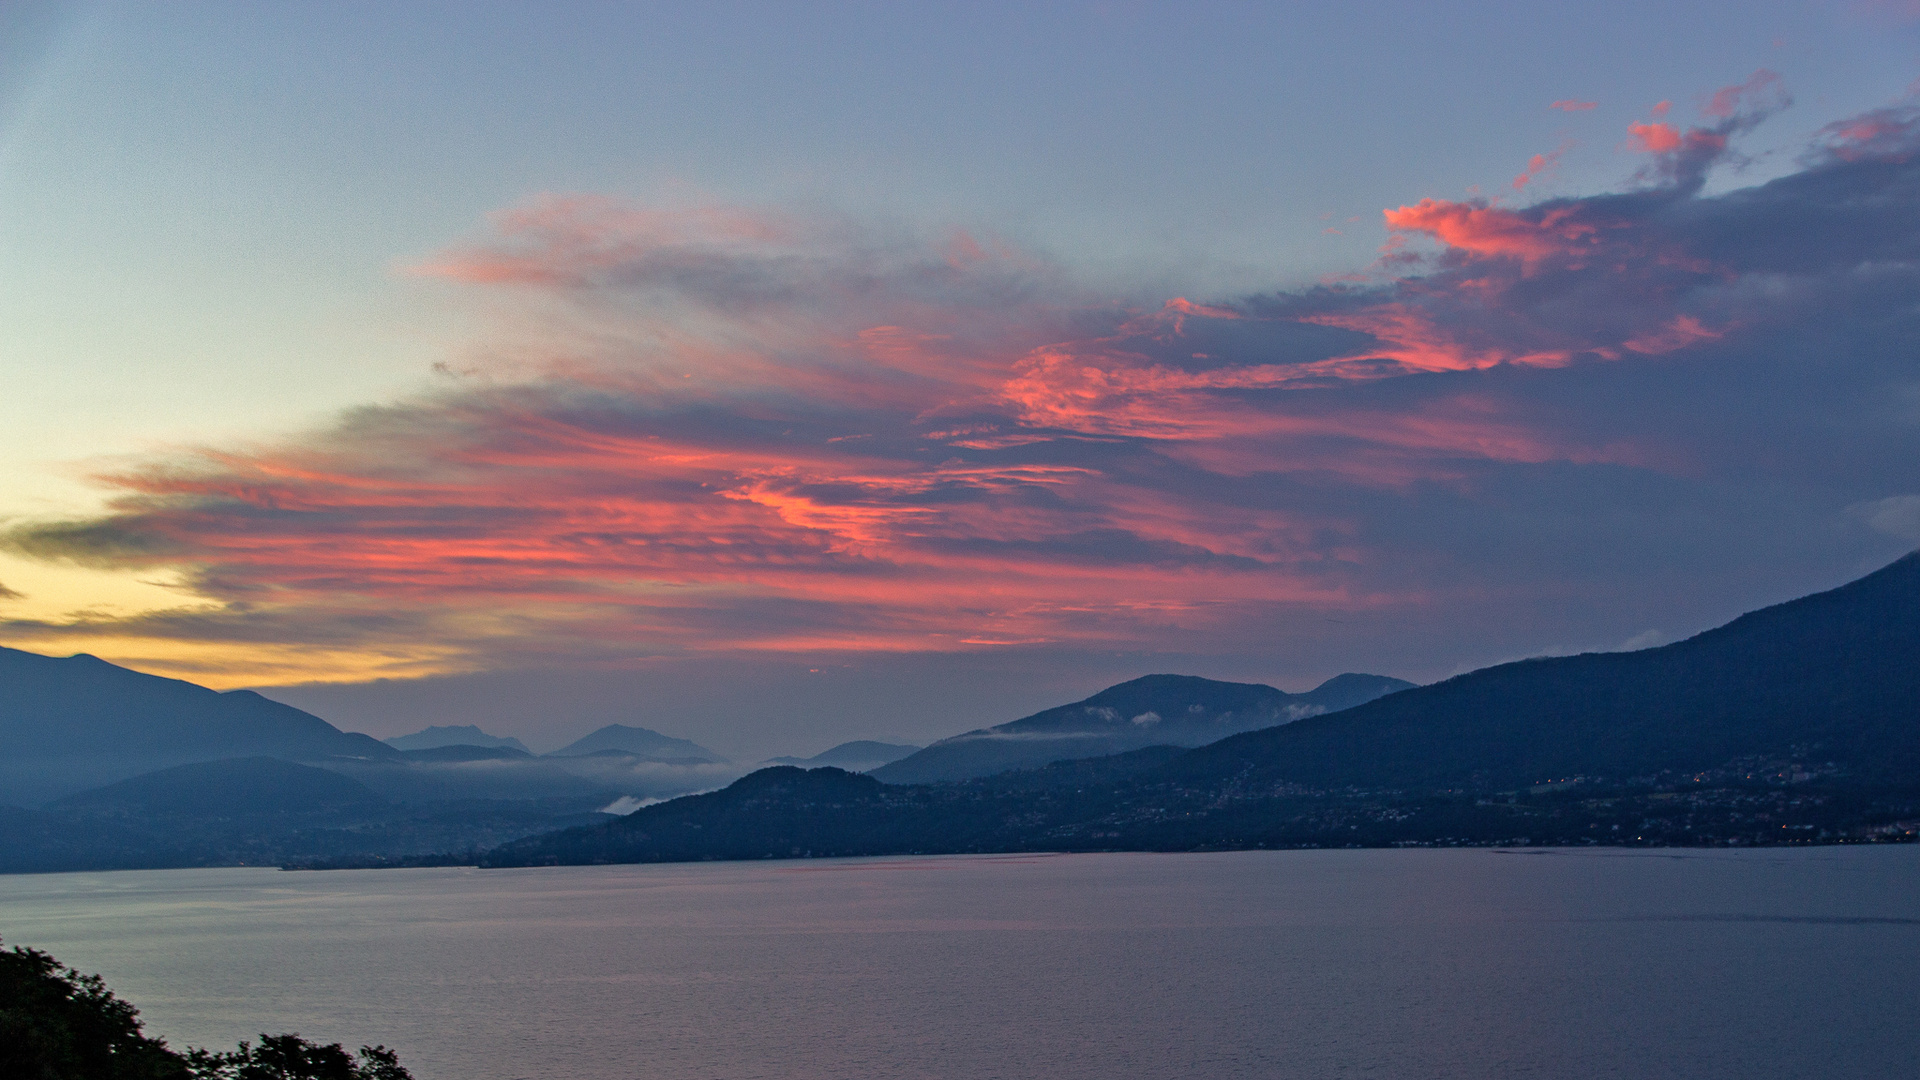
[872,675,1413,784]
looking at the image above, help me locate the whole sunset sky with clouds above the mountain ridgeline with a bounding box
[0,2,1920,757]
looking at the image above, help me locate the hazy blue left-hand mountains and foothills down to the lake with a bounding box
[0,661,714,872]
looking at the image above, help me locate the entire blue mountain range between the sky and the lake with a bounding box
[0,553,1920,871]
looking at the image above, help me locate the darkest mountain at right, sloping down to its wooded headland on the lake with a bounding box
[480,553,1920,865]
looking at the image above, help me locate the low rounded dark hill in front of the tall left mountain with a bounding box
[48,757,386,817]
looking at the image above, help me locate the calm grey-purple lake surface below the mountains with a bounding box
[0,847,1920,1080]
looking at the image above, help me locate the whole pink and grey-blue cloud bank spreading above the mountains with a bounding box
[0,73,1920,682]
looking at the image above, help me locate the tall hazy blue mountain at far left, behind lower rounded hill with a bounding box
[0,648,399,805]
